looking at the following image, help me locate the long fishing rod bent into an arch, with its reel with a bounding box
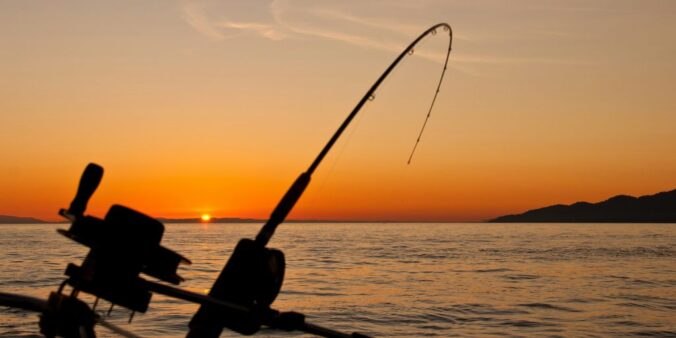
[187,23,453,338]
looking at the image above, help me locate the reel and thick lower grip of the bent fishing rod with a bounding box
[187,173,310,338]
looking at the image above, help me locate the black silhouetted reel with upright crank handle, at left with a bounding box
[57,163,190,312]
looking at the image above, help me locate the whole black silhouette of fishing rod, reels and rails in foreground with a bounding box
[0,23,453,338]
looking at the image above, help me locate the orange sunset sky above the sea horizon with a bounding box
[0,1,676,221]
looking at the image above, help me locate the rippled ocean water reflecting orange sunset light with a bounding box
[0,224,676,337]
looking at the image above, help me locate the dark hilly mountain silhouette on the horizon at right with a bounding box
[490,190,676,223]
